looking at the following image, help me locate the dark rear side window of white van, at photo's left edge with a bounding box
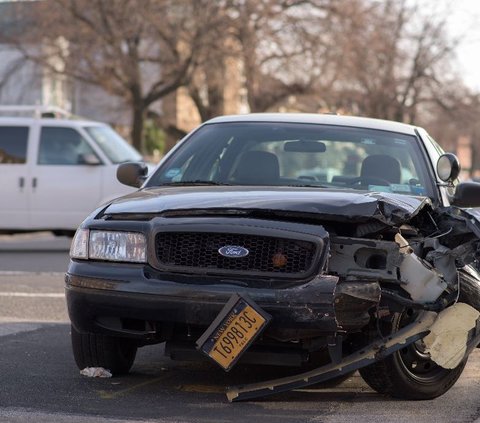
[0,126,28,164]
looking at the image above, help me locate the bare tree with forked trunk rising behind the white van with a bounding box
[7,0,221,149]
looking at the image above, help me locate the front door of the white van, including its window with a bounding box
[30,126,103,229]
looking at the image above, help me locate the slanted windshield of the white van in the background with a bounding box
[85,125,142,164]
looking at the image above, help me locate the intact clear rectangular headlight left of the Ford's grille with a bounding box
[71,229,147,263]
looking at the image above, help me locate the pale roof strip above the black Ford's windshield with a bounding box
[205,113,416,135]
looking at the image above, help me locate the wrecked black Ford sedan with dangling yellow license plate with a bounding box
[65,114,480,401]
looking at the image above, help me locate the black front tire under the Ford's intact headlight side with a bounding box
[71,326,137,375]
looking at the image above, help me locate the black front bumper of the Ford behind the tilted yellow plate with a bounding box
[65,261,375,340]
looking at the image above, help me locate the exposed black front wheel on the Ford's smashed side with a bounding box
[359,310,467,400]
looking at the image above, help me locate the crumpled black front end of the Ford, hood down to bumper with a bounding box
[66,188,480,398]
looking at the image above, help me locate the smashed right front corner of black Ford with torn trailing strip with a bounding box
[227,203,480,401]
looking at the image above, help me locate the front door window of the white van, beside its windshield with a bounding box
[37,127,96,165]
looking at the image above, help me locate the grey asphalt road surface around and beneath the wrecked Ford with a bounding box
[0,235,480,423]
